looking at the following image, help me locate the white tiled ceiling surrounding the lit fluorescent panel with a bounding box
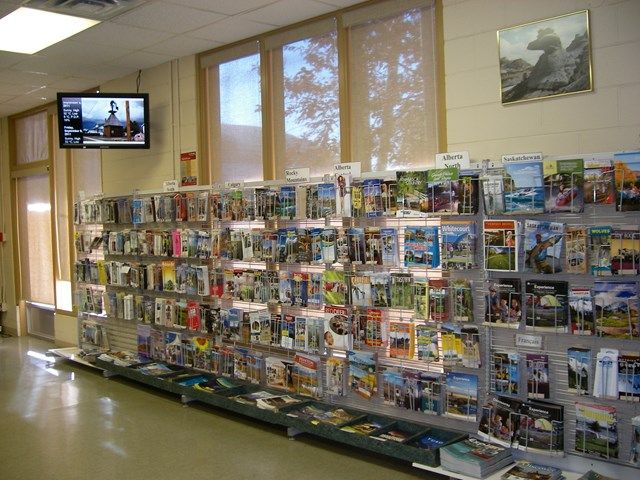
[0,0,362,117]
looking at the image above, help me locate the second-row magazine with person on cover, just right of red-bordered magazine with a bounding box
[524,220,564,274]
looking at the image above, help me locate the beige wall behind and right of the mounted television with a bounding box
[101,55,198,195]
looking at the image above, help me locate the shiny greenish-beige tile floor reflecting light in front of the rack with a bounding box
[0,337,440,480]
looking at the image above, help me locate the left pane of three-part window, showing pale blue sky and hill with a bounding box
[207,45,263,182]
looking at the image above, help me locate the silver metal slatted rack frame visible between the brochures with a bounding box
[76,163,640,478]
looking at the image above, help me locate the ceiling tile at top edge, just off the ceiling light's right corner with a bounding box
[113,3,225,33]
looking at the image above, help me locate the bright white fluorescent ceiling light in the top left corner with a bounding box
[0,7,100,54]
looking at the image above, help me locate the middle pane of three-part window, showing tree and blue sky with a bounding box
[274,21,340,178]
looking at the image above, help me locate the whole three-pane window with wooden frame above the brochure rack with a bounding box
[199,0,439,182]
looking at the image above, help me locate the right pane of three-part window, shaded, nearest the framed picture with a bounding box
[349,3,438,171]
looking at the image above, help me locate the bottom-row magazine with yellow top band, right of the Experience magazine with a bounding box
[575,402,620,459]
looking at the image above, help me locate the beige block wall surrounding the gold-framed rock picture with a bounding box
[444,0,640,159]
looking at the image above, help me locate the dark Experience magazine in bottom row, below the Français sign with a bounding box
[518,400,564,454]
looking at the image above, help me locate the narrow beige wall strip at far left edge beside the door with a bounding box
[0,117,18,334]
